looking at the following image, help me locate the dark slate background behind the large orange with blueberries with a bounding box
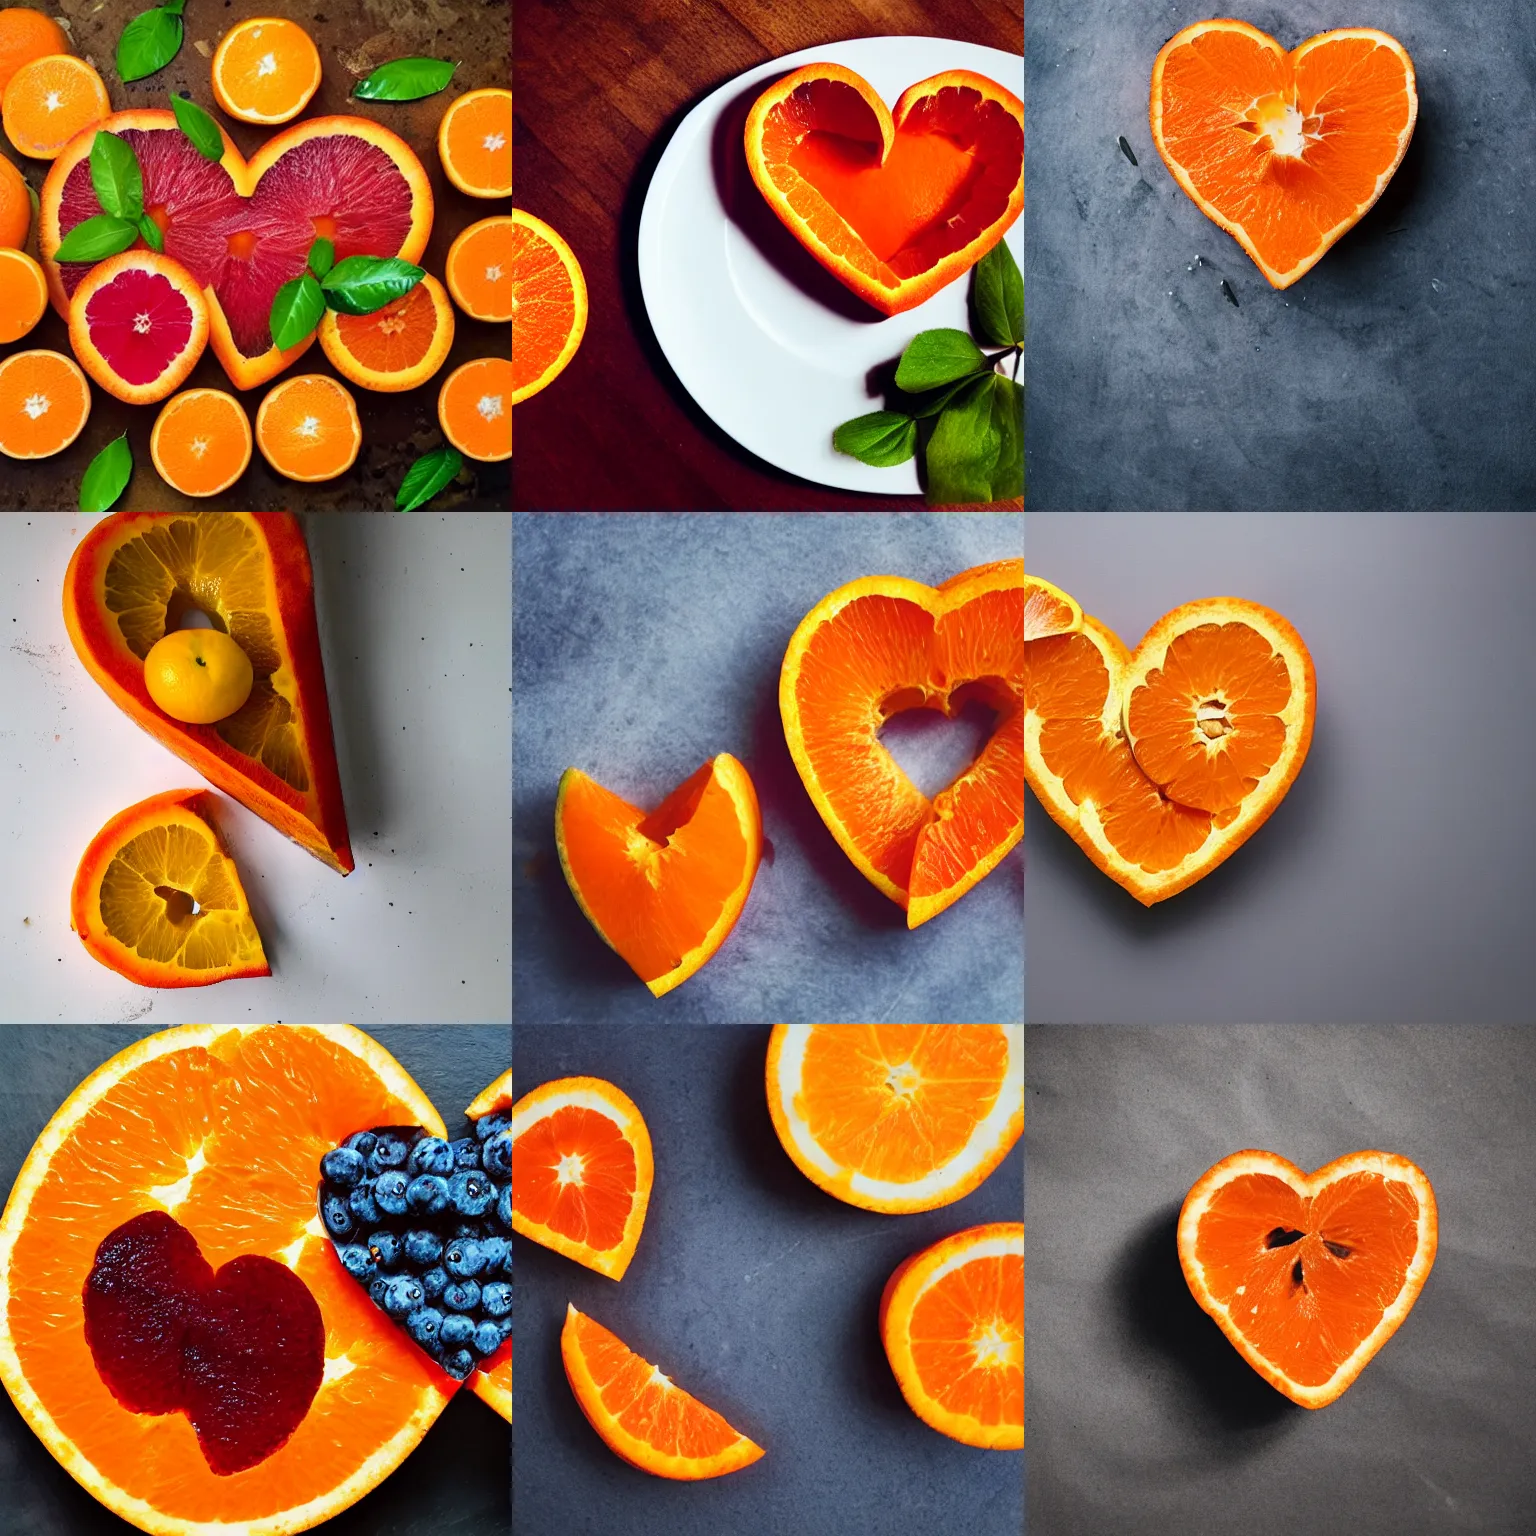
[0,1025,511,1536]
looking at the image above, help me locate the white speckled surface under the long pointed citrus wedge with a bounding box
[0,513,511,1025]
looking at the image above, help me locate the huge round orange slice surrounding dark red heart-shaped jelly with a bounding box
[0,1025,447,1536]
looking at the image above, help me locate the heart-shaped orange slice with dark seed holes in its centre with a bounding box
[1178,1150,1439,1409]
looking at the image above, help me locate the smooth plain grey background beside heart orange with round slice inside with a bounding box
[1025,513,1536,1025]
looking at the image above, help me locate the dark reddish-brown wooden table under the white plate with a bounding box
[513,0,1025,511]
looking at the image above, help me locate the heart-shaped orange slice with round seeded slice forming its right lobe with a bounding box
[1025,588,1316,906]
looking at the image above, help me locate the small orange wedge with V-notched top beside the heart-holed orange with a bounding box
[554,753,763,997]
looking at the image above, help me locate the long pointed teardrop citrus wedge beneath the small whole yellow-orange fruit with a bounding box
[65,511,352,874]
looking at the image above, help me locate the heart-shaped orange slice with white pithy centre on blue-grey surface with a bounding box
[1150,20,1419,289]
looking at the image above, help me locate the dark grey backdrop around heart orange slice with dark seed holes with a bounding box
[1026,1026,1536,1536]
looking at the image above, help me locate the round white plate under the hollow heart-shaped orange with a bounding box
[639,37,1025,496]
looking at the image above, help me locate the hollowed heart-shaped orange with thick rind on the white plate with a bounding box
[745,63,1025,315]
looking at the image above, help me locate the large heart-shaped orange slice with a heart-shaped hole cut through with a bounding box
[779,559,1025,928]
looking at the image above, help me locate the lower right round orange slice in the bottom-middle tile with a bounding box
[880,1221,1025,1450]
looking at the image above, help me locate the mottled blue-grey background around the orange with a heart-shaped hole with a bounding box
[513,513,1025,1023]
